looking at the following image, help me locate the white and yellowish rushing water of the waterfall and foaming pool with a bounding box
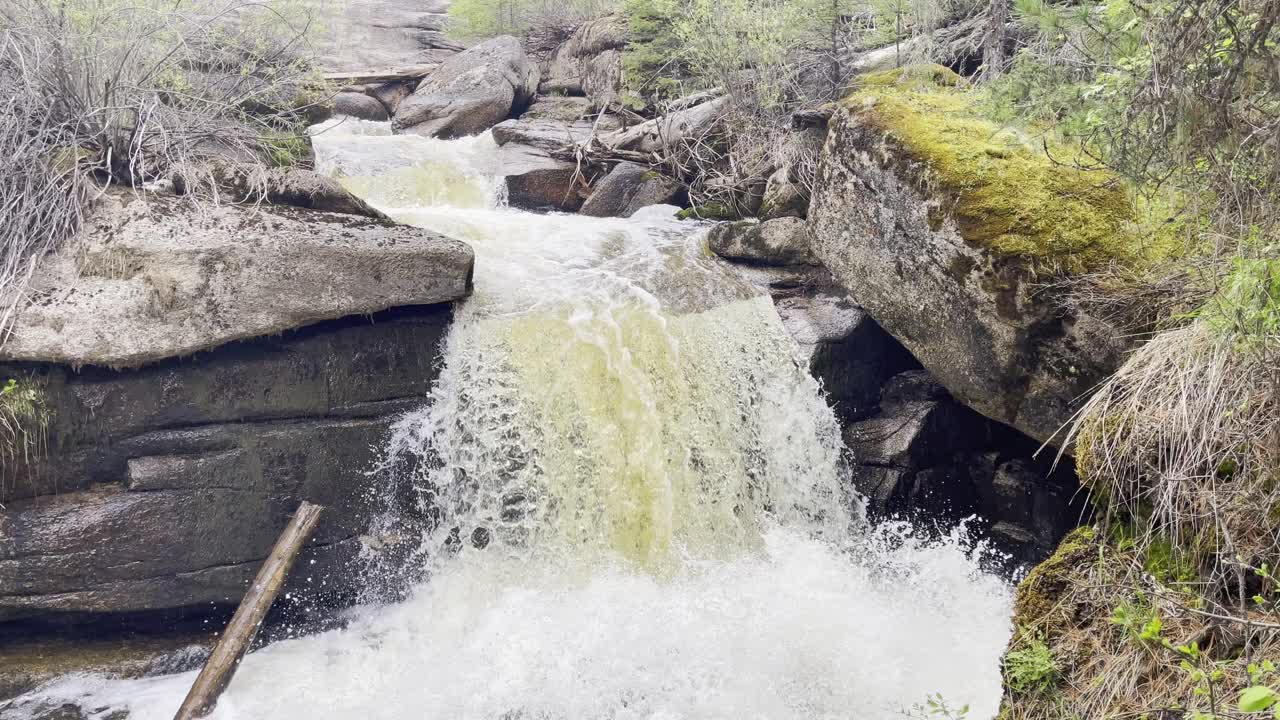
[7,120,1009,720]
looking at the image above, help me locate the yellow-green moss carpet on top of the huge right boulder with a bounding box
[845,65,1179,273]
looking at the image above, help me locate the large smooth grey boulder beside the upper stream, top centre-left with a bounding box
[392,35,538,138]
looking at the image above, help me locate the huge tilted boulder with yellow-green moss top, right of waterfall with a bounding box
[809,67,1160,441]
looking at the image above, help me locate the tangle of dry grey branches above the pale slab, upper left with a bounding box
[0,0,328,342]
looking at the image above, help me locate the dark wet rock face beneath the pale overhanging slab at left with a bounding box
[0,306,449,625]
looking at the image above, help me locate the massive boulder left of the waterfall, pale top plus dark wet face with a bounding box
[0,192,472,622]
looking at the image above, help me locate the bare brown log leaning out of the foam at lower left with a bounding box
[174,501,324,720]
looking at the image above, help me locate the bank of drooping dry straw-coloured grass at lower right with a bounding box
[1004,283,1280,719]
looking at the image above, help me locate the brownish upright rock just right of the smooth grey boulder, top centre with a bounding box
[539,15,628,108]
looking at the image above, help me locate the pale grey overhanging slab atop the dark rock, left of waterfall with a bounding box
[0,193,472,368]
